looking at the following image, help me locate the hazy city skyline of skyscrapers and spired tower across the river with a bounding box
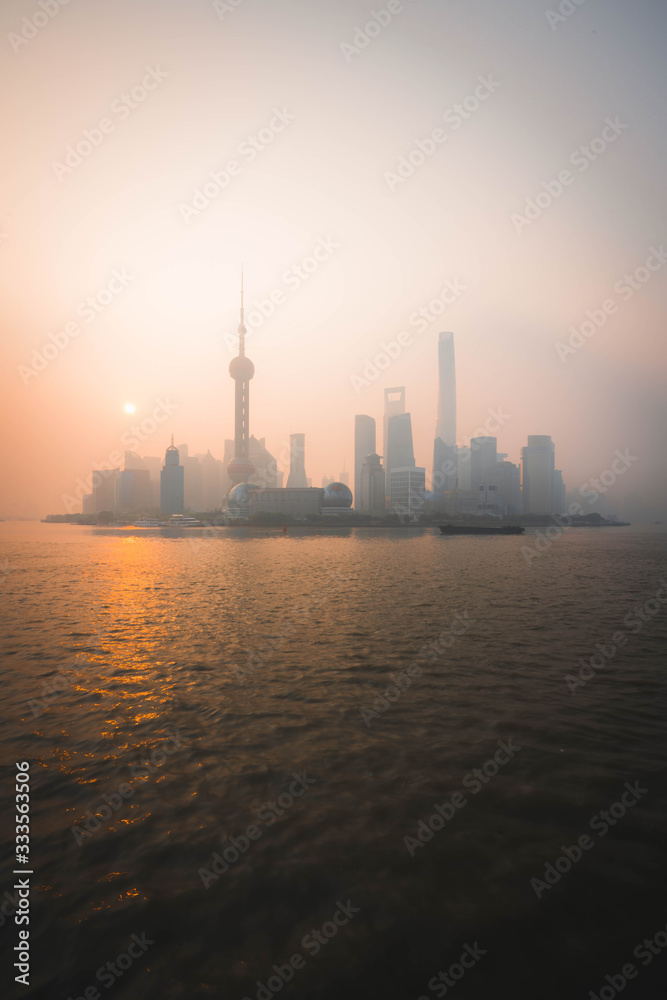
[63,314,620,520]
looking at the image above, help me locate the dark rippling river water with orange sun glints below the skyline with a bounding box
[0,523,667,1000]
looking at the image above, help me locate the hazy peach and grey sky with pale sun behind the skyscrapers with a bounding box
[0,0,667,518]
